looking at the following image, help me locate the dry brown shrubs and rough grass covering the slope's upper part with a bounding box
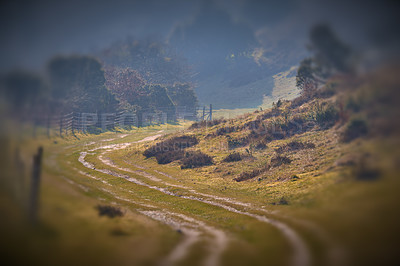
[139,66,400,179]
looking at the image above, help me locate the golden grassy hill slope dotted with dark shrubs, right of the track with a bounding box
[140,66,400,265]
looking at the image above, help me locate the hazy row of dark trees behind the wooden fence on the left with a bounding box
[0,38,198,120]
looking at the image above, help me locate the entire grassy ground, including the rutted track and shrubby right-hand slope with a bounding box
[0,67,400,266]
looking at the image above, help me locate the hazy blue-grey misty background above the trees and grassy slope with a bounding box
[0,0,399,108]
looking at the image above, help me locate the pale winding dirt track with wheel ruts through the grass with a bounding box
[68,132,340,266]
